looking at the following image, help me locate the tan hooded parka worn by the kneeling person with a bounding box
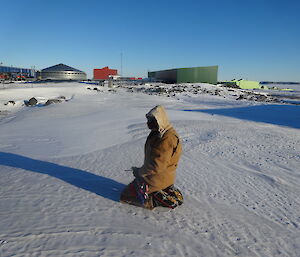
[138,105,182,194]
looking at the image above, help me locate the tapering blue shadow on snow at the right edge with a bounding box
[184,104,300,129]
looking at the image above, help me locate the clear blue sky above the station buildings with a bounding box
[0,0,300,81]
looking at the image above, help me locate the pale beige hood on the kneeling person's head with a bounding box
[146,105,172,137]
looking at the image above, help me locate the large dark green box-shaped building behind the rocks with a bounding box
[148,66,218,85]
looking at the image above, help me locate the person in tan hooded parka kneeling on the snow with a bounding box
[120,105,183,209]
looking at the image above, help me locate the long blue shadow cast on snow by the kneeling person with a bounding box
[0,152,125,201]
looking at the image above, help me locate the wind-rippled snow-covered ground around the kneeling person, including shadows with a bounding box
[0,83,300,257]
